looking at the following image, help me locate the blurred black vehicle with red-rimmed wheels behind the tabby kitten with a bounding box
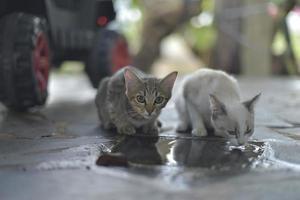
[0,0,130,111]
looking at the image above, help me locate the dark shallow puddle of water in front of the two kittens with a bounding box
[105,137,265,171]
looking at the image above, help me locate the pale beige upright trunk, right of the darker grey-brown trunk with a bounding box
[242,0,273,75]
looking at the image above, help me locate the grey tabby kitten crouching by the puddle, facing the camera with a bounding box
[95,67,177,135]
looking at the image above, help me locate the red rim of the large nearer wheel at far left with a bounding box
[33,33,50,92]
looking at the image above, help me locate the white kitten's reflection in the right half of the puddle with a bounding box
[173,139,264,171]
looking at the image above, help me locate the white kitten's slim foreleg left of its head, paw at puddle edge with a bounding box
[187,103,207,137]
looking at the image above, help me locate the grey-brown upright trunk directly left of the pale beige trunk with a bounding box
[210,0,243,74]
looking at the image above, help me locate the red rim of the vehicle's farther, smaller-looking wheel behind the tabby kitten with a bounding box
[111,39,131,73]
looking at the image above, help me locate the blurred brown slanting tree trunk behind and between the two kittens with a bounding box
[133,0,200,72]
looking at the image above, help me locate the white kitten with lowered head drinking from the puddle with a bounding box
[175,69,260,144]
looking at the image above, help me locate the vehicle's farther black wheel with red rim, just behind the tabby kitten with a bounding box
[85,29,131,88]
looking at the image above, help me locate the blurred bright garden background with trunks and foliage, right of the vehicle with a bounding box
[115,0,300,75]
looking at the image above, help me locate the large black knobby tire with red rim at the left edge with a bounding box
[0,13,50,111]
